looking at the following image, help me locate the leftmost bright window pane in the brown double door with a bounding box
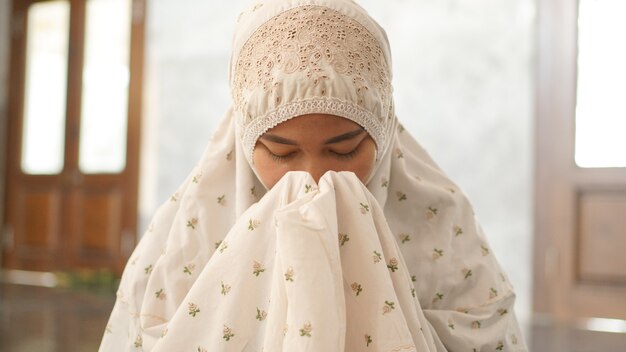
[21,1,70,175]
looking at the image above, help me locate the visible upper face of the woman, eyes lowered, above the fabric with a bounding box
[254,114,376,188]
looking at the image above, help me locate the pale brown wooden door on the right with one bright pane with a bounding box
[534,0,626,323]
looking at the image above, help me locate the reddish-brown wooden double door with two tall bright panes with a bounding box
[3,0,144,272]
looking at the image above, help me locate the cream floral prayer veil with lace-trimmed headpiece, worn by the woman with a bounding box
[101,0,526,351]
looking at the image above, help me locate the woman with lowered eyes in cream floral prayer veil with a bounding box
[101,0,526,351]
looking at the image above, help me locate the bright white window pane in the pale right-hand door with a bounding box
[575,0,626,168]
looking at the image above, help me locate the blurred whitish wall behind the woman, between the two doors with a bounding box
[141,0,534,332]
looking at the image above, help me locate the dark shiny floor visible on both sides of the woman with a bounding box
[0,283,626,352]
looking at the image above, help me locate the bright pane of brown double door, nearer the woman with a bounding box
[79,0,131,173]
